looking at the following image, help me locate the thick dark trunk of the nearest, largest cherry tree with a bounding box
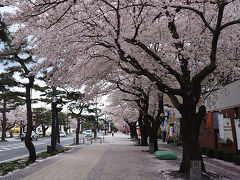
[180,103,206,173]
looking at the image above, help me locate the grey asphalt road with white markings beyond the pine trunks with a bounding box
[0,135,78,162]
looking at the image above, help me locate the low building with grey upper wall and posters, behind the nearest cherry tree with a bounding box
[199,80,240,153]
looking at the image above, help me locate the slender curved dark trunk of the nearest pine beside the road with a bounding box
[25,77,36,163]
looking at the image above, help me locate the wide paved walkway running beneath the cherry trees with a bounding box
[0,133,166,180]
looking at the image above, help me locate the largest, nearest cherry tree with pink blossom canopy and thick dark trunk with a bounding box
[3,0,240,172]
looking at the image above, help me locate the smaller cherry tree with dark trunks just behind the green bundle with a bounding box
[108,78,164,151]
